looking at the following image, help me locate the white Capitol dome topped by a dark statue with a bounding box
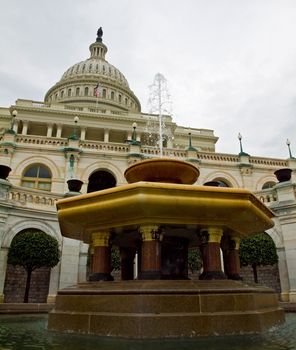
[44,28,141,112]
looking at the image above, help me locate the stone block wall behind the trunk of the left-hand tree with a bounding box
[4,264,50,303]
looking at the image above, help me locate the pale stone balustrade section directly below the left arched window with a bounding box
[8,186,63,211]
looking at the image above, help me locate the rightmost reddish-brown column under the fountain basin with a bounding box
[224,236,242,280]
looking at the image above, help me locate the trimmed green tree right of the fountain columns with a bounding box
[240,233,278,283]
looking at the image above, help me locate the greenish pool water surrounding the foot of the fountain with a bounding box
[0,314,296,350]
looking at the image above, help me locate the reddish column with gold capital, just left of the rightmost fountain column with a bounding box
[199,227,226,280]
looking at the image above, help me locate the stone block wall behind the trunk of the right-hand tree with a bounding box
[240,265,281,293]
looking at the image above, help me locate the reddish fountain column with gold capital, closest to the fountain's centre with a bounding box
[139,225,161,280]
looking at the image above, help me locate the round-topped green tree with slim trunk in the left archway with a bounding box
[8,230,60,303]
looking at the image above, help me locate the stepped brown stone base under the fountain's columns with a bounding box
[48,280,284,338]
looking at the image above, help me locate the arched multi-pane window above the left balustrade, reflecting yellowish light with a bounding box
[22,164,51,191]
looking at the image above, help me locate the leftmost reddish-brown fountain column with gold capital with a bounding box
[89,231,113,281]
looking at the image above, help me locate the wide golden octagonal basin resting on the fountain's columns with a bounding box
[57,182,274,243]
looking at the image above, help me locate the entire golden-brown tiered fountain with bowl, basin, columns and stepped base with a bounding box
[48,158,284,338]
